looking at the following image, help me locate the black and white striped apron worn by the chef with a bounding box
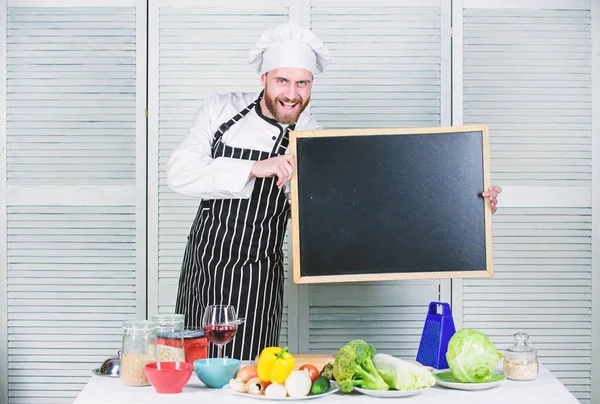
[175,93,293,360]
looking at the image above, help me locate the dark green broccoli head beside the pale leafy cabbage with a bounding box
[333,340,389,393]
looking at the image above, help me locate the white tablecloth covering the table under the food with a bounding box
[74,367,579,404]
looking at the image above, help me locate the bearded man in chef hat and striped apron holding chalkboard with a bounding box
[167,23,499,360]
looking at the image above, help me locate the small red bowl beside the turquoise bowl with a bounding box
[144,362,194,394]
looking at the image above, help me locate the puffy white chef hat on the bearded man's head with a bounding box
[248,22,329,75]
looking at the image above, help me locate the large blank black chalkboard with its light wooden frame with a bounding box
[290,125,493,283]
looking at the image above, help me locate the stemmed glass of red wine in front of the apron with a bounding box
[202,304,243,358]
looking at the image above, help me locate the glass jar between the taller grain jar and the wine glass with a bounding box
[151,314,185,362]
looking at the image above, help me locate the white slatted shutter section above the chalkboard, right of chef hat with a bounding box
[311,0,442,129]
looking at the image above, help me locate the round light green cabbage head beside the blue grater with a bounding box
[446,329,502,383]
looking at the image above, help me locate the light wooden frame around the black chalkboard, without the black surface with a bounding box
[290,125,494,284]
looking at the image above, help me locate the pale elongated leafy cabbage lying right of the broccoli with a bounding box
[373,354,435,390]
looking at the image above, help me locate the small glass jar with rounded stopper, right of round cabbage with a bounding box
[504,332,540,381]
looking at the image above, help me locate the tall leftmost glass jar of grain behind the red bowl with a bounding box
[119,320,156,386]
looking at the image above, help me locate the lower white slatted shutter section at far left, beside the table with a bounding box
[7,206,136,404]
